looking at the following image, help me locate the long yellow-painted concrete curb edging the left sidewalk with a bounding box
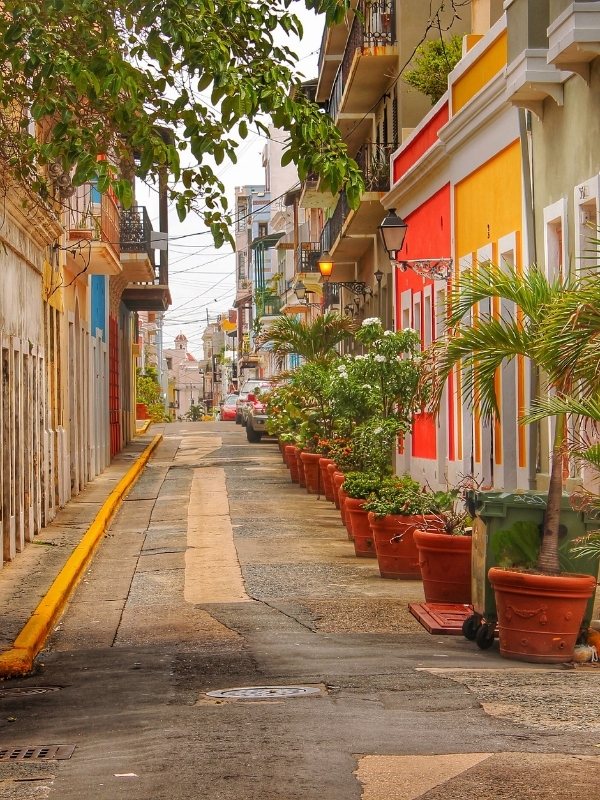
[0,434,163,678]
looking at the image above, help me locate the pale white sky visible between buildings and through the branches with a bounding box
[137,2,323,358]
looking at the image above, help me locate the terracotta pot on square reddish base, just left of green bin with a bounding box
[413,530,472,603]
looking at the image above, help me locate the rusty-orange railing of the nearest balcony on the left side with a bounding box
[68,183,121,255]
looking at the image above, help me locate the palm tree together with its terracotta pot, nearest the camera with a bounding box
[433,264,600,663]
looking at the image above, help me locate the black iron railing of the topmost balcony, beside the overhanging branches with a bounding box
[329,0,396,120]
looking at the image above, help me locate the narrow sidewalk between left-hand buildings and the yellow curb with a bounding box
[0,426,161,672]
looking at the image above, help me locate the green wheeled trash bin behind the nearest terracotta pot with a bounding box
[463,491,600,649]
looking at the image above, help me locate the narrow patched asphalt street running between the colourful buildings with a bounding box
[0,423,600,800]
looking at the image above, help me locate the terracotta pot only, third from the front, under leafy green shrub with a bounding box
[369,511,441,580]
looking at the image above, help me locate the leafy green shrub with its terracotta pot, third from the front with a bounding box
[364,475,449,579]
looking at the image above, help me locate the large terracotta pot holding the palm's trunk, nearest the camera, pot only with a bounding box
[488,567,596,664]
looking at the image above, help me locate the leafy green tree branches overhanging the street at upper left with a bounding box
[0,0,362,244]
